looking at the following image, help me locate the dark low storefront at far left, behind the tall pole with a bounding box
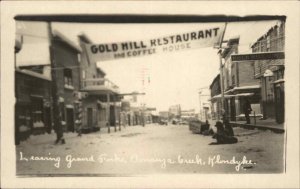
[15,69,52,144]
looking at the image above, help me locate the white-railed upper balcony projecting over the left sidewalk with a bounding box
[81,78,120,95]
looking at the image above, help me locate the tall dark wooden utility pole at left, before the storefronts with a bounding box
[48,22,65,144]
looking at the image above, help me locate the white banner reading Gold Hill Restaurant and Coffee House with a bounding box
[85,26,224,62]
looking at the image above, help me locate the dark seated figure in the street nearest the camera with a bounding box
[213,121,238,144]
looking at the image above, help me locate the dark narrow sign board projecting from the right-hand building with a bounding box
[231,52,284,61]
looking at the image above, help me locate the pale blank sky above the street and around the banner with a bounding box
[16,21,276,112]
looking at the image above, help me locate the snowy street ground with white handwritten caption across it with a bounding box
[16,124,284,176]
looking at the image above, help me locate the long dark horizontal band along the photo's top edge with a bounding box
[14,14,286,23]
